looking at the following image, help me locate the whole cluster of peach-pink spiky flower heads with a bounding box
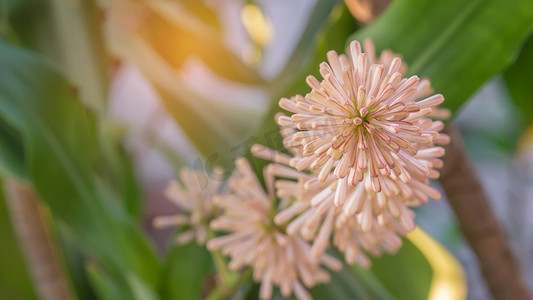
[155,40,449,300]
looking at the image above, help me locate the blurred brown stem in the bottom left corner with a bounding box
[4,179,74,300]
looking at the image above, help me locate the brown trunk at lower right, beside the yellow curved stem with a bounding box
[440,124,531,300]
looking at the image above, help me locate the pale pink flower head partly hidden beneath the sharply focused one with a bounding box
[251,145,408,267]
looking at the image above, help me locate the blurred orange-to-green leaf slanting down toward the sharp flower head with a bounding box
[111,31,264,168]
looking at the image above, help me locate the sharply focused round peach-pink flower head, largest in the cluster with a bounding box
[278,41,448,192]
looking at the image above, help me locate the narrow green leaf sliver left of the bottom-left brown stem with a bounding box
[0,185,37,300]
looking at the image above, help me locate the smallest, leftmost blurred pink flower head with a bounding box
[154,168,224,245]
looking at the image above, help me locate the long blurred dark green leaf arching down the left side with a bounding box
[0,38,159,287]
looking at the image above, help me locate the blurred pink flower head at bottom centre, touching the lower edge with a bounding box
[207,158,342,299]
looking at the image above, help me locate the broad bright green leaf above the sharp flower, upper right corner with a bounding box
[349,0,533,111]
